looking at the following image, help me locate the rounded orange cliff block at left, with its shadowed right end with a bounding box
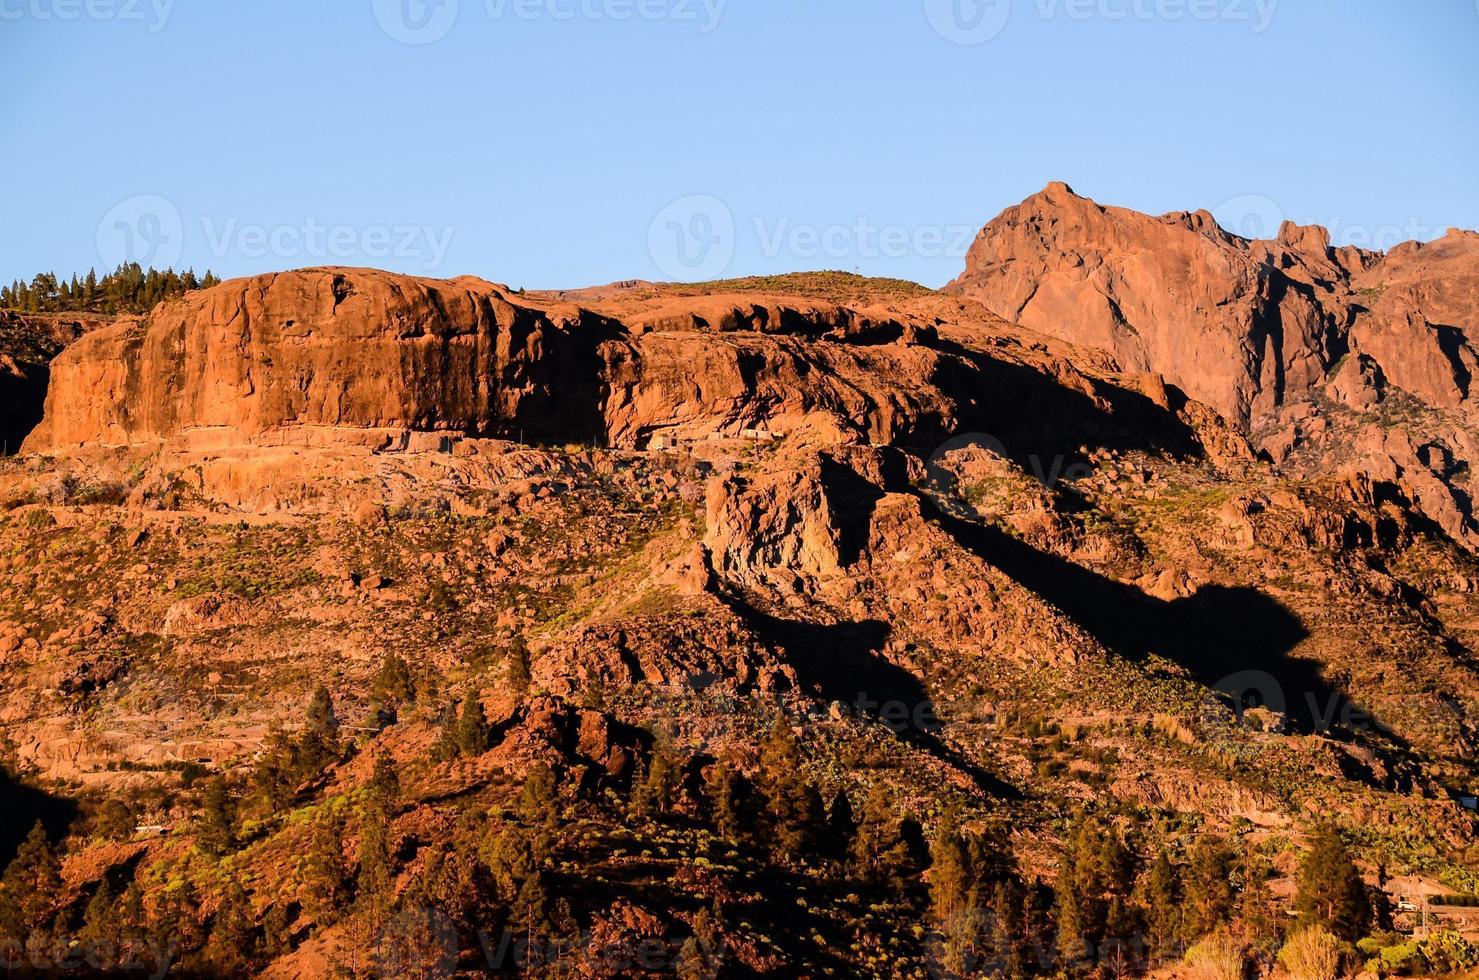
[27,269,609,449]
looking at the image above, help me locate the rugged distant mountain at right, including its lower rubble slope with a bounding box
[945,183,1479,544]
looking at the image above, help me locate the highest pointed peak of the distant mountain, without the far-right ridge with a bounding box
[947,183,1367,424]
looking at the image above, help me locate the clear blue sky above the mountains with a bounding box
[0,0,1479,287]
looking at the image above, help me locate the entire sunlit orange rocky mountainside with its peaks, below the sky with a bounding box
[0,185,1479,977]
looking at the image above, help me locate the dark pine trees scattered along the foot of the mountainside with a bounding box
[0,647,1386,979]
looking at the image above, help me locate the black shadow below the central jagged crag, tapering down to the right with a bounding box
[723,596,1021,798]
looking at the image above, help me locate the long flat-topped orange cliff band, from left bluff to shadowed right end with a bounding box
[25,260,1200,452]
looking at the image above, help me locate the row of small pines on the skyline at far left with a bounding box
[0,262,220,315]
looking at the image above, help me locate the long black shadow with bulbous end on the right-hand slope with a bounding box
[926,501,1384,732]
